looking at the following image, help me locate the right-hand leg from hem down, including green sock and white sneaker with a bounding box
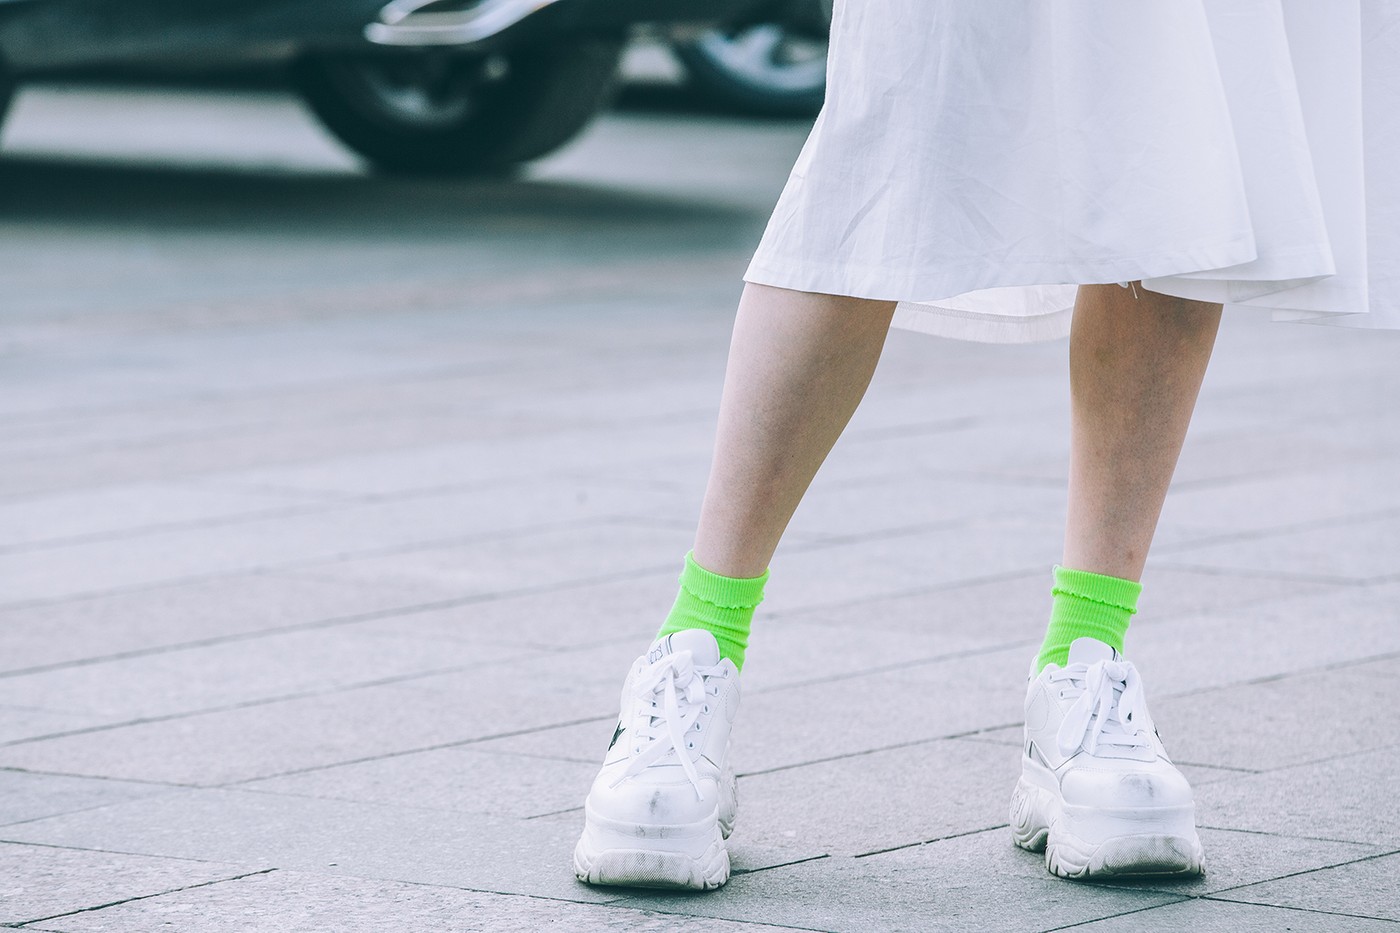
[1011,284,1221,878]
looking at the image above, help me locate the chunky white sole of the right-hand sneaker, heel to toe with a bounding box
[1011,776,1205,878]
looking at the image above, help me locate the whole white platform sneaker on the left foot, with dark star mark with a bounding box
[574,629,739,891]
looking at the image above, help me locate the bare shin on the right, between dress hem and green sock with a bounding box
[1063,284,1221,580]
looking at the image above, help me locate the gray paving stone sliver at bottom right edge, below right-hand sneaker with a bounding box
[1075,899,1394,933]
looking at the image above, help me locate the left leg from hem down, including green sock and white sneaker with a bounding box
[574,277,895,890]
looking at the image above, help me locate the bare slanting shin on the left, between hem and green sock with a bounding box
[694,284,895,577]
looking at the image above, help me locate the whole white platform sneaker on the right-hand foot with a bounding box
[1011,639,1204,878]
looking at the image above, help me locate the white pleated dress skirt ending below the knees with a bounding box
[745,0,1400,342]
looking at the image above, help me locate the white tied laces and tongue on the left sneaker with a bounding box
[612,651,707,800]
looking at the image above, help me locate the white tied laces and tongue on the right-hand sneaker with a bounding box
[1050,652,1149,755]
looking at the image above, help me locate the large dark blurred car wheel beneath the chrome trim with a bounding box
[295,41,622,175]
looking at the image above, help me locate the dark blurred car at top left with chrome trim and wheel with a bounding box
[0,0,755,174]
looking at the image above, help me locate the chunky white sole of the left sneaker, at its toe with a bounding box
[574,806,732,891]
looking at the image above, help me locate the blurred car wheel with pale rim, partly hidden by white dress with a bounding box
[675,0,832,116]
